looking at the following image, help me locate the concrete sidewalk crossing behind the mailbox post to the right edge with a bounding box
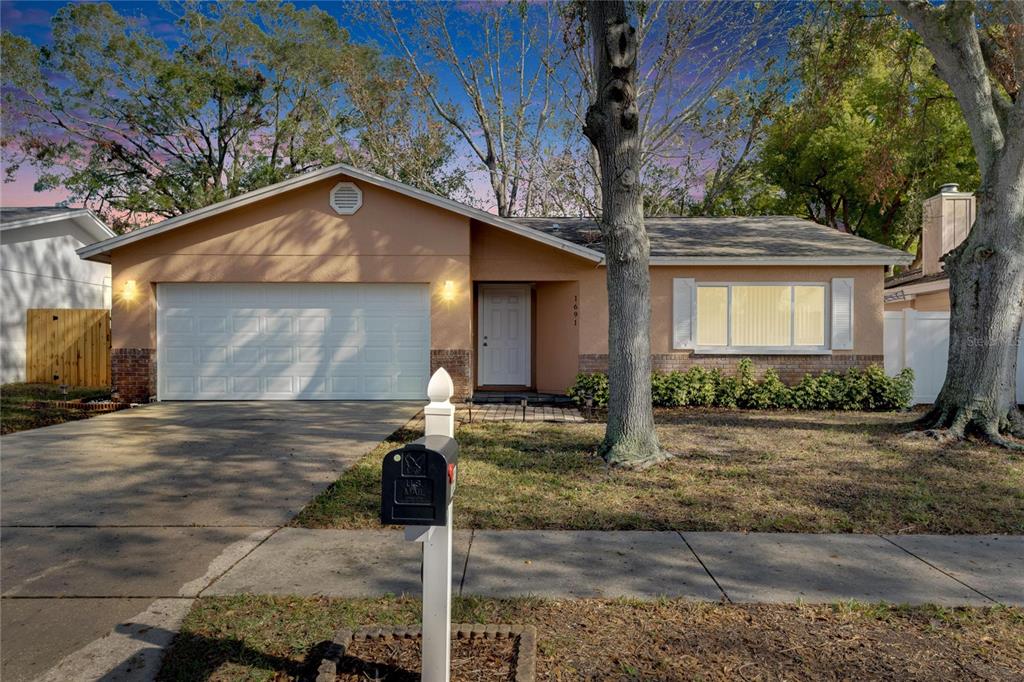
[201,528,1024,606]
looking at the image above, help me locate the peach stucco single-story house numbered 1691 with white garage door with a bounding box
[79,165,910,400]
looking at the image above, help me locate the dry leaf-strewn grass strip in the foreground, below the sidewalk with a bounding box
[158,596,1024,682]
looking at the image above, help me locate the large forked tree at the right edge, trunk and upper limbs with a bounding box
[889,0,1024,450]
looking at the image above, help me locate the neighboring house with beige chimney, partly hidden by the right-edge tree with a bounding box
[885,184,977,312]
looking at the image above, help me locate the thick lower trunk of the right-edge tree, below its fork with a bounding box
[922,173,1024,447]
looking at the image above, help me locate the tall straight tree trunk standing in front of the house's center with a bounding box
[584,0,665,467]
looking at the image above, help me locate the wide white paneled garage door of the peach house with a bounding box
[157,284,430,400]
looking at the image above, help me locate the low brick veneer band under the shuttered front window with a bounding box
[580,352,885,384]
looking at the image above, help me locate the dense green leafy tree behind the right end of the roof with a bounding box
[760,3,978,249]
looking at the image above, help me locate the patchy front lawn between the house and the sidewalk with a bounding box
[293,410,1024,534]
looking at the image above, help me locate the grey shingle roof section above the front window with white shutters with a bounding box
[513,216,911,263]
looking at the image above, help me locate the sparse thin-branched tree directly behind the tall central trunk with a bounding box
[549,0,792,217]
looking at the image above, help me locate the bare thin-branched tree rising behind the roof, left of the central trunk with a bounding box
[372,1,556,217]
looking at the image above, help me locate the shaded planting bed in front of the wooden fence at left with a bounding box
[0,384,113,434]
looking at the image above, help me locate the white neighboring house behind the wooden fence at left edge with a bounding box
[0,206,115,383]
